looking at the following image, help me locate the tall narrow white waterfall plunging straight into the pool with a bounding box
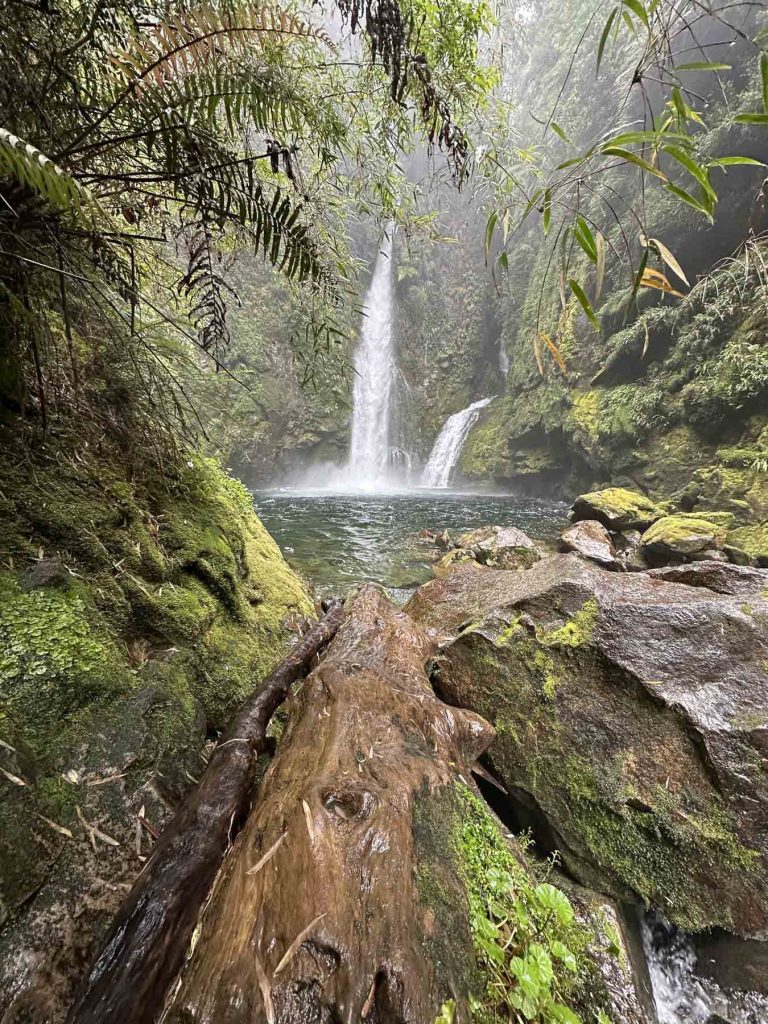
[347,231,396,489]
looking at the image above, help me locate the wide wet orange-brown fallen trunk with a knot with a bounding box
[165,587,494,1024]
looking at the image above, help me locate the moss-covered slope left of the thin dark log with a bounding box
[0,435,312,1020]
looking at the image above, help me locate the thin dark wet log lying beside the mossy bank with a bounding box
[68,601,344,1024]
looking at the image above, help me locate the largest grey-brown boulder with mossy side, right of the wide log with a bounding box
[407,555,768,938]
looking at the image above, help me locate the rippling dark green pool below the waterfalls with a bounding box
[254,490,567,594]
